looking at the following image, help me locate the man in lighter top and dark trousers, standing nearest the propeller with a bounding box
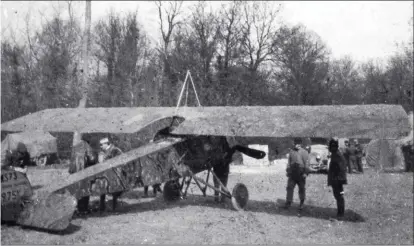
[284,138,309,211]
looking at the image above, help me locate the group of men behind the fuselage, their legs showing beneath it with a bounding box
[69,138,162,215]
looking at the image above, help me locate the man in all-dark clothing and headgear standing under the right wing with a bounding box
[328,137,347,219]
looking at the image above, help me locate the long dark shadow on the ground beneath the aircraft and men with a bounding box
[81,191,365,223]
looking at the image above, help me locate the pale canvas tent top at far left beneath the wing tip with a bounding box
[1,131,57,158]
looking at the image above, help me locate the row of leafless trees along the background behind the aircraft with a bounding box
[1,1,413,122]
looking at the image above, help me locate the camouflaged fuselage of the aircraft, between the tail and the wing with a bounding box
[37,138,182,199]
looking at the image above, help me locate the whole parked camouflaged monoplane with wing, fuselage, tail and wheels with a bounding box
[1,105,409,233]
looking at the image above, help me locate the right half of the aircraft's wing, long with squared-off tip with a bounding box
[173,105,410,139]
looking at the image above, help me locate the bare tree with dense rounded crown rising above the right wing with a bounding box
[272,25,329,105]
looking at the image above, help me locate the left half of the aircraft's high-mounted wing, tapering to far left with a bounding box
[1,107,174,133]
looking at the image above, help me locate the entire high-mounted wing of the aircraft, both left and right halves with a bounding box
[2,104,410,139]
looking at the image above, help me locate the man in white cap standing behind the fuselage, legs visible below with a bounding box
[99,138,122,211]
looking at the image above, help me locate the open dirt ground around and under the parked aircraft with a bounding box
[1,164,413,244]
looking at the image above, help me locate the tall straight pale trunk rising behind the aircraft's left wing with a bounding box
[72,0,91,146]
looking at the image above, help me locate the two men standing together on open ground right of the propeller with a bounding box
[284,137,348,219]
